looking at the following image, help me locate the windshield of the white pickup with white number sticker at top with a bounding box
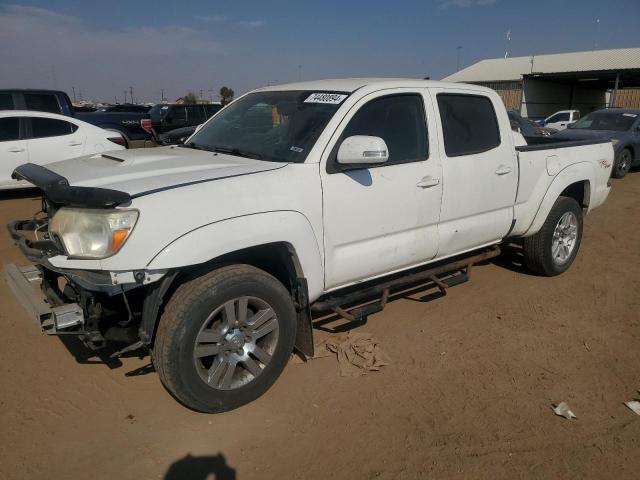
[184,91,348,163]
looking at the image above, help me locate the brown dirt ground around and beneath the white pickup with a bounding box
[0,172,640,480]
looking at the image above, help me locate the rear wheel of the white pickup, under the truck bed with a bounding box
[524,197,583,277]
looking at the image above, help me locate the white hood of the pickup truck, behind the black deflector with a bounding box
[46,147,286,196]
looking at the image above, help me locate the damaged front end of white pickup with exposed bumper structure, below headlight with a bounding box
[5,219,176,351]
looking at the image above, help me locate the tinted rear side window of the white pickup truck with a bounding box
[437,93,500,157]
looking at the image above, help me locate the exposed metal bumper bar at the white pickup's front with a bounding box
[4,264,85,335]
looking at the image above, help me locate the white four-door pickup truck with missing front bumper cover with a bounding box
[6,79,613,412]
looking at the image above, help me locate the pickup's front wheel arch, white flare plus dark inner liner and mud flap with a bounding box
[140,211,324,356]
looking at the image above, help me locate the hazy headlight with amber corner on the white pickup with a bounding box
[49,208,139,258]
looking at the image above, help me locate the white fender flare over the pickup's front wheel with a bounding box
[147,210,324,300]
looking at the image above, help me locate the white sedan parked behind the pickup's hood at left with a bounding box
[0,110,125,190]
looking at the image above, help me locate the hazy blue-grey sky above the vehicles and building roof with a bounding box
[0,0,640,102]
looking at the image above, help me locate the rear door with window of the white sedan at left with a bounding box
[25,117,86,165]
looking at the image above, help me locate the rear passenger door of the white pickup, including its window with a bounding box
[431,89,518,257]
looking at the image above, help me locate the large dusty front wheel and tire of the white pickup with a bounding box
[152,265,296,413]
